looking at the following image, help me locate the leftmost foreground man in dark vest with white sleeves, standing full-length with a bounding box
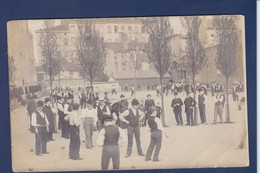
[31,100,49,156]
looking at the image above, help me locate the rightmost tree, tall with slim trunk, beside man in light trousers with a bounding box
[213,15,239,123]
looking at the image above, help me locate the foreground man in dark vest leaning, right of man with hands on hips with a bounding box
[145,108,167,162]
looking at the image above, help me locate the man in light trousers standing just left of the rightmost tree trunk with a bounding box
[213,92,225,124]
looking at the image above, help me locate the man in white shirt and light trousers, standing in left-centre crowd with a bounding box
[81,100,97,149]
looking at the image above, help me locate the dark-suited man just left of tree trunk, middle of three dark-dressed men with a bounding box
[184,91,196,126]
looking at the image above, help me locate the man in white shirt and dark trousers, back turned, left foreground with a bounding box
[64,103,82,160]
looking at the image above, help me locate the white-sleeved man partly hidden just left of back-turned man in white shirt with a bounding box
[61,96,73,139]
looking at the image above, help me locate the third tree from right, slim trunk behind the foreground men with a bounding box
[143,17,173,126]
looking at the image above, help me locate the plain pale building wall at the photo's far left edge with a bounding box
[7,20,37,87]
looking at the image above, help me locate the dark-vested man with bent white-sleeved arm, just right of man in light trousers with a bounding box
[97,100,111,131]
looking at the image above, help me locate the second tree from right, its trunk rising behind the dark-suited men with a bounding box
[182,16,207,125]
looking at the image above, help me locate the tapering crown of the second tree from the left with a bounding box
[76,19,106,100]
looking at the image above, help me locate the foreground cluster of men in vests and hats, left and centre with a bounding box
[30,90,167,170]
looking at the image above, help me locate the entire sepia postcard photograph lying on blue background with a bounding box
[7,15,249,172]
